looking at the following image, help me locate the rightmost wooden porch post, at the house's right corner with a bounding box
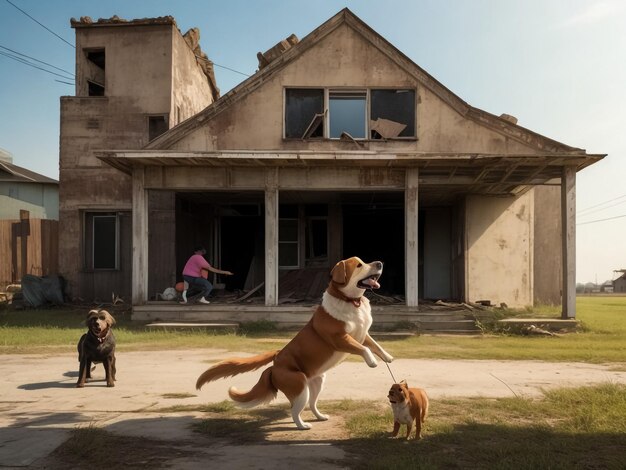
[561,167,576,319]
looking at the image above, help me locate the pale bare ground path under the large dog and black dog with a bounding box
[0,349,626,470]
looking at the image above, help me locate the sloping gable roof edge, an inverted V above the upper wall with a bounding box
[145,8,585,155]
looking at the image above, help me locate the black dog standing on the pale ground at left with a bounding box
[76,310,115,387]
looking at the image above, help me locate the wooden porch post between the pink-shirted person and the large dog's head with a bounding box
[265,168,278,306]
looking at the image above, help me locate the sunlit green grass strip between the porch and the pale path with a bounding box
[0,297,626,367]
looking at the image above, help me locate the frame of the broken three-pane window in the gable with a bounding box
[282,86,419,142]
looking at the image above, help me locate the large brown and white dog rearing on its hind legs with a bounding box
[196,257,393,429]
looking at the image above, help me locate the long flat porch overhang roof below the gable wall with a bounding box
[96,150,605,196]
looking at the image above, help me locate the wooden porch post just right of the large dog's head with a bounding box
[404,168,419,307]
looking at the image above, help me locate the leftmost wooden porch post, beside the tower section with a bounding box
[131,168,148,305]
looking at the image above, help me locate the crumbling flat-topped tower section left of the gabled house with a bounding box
[59,17,219,300]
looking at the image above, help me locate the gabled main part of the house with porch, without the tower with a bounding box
[61,9,603,317]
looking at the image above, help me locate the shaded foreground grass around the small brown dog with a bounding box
[183,383,626,470]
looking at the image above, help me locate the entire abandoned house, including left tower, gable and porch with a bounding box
[60,9,604,324]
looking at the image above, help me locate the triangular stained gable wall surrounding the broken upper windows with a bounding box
[173,25,534,154]
